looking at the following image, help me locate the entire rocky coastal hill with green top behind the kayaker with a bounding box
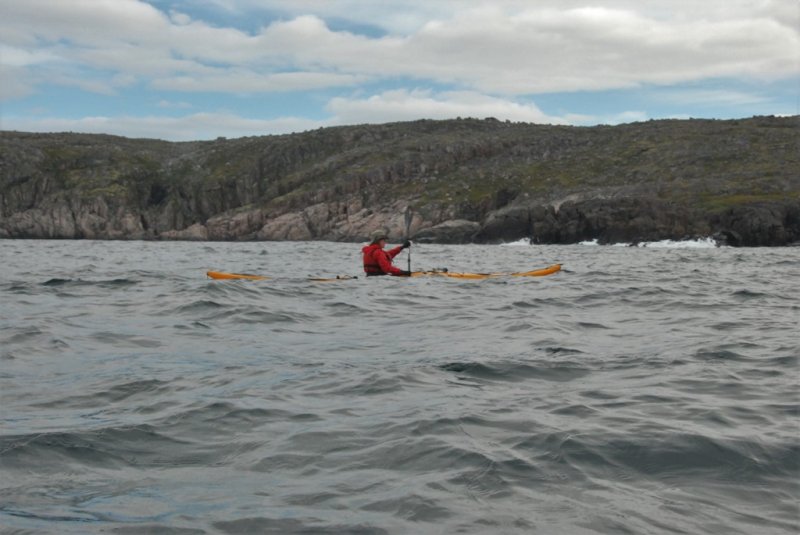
[0,117,800,245]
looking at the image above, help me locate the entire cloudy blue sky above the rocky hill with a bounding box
[0,0,800,141]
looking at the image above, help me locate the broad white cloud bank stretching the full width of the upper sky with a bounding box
[0,0,800,95]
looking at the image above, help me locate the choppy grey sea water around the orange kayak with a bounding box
[0,240,800,535]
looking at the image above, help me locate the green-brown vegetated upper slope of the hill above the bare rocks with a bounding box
[0,117,800,245]
